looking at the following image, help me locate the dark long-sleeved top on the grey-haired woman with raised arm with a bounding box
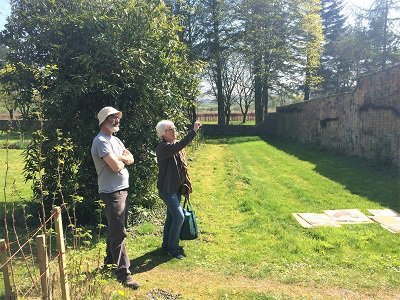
[156,130,196,194]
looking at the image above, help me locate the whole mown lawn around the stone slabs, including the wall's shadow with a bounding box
[0,137,400,299]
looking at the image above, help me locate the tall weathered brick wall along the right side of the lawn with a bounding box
[257,67,400,167]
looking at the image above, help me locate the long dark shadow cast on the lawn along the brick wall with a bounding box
[261,137,400,211]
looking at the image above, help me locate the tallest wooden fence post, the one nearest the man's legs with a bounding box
[53,206,70,300]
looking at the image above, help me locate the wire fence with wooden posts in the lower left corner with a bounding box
[0,190,112,300]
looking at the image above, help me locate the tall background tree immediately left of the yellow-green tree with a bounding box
[237,0,299,124]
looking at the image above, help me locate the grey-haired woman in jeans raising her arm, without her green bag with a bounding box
[156,120,201,259]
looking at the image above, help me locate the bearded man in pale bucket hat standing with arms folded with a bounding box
[91,106,140,289]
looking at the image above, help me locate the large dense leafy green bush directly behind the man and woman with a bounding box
[1,0,202,222]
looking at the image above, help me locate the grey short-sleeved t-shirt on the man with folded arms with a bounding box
[91,132,129,193]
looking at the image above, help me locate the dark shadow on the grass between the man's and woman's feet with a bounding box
[130,248,172,274]
